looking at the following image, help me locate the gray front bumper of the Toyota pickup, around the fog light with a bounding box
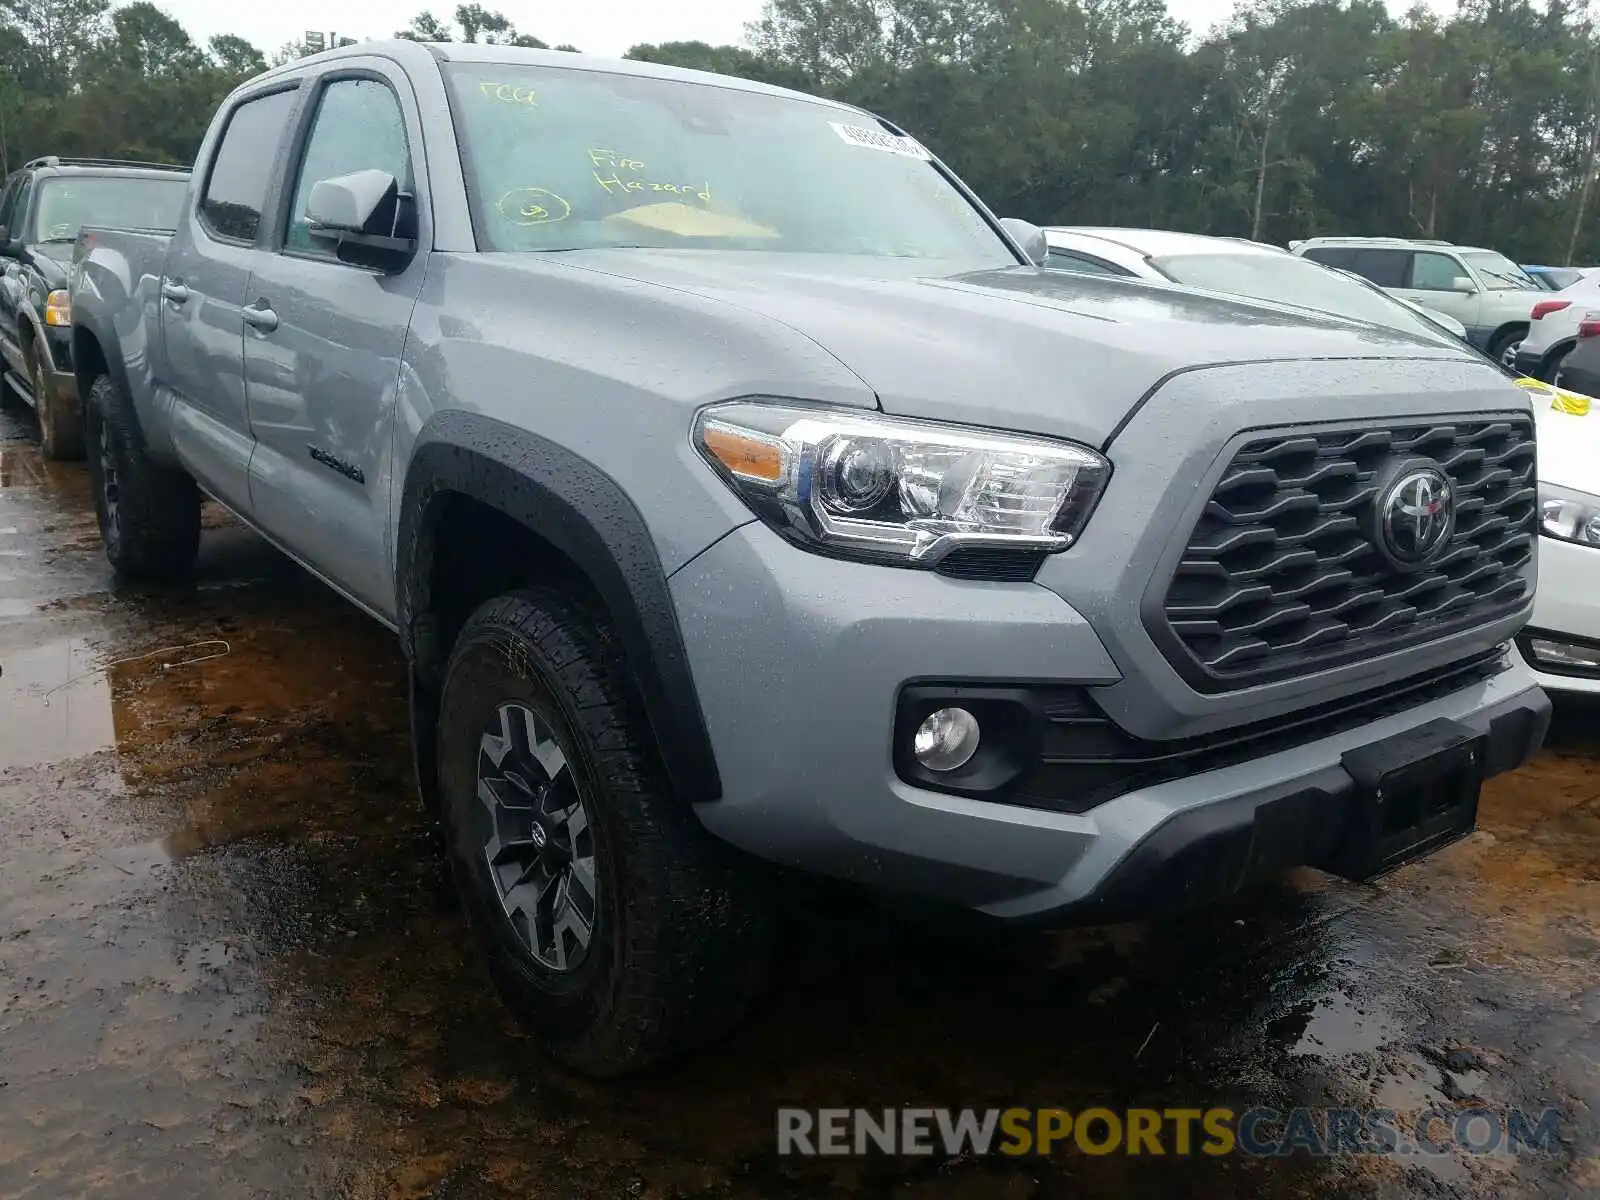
[672,525,1549,923]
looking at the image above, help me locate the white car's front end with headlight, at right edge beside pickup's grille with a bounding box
[1517,380,1600,696]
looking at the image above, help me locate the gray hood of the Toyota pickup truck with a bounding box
[560,250,1470,445]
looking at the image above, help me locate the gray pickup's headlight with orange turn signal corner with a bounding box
[694,402,1110,566]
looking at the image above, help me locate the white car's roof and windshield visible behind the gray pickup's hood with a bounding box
[1045,226,1466,345]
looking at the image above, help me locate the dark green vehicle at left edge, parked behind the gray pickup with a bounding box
[0,157,189,459]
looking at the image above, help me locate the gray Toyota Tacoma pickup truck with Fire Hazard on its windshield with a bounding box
[72,43,1549,1074]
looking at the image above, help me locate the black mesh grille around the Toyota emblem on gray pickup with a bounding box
[1157,416,1536,691]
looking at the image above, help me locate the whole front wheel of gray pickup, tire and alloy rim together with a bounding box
[438,589,766,1075]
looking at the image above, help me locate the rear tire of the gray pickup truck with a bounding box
[85,374,200,582]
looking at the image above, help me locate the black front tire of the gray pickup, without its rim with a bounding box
[438,589,768,1077]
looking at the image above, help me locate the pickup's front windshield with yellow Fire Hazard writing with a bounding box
[448,62,1016,269]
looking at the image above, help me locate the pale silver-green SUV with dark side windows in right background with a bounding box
[1290,237,1546,366]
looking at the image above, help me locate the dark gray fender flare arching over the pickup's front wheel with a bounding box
[395,410,722,802]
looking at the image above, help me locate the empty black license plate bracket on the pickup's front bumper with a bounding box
[1334,720,1483,880]
